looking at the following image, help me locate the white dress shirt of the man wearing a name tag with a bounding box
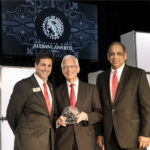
[34,73,52,108]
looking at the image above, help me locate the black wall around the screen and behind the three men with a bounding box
[0,0,150,86]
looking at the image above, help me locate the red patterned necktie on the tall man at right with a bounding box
[112,70,118,103]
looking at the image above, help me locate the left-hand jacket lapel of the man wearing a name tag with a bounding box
[31,75,49,115]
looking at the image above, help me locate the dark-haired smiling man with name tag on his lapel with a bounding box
[7,52,54,150]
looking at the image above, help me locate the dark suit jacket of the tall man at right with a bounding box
[97,65,150,148]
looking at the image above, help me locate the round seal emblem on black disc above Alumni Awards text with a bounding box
[35,8,70,43]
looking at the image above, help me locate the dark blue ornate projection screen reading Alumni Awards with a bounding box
[1,0,98,60]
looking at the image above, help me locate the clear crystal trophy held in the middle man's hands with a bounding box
[62,106,80,124]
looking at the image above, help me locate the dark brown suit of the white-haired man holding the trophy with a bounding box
[55,81,102,150]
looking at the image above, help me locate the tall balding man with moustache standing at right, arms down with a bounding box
[97,42,150,150]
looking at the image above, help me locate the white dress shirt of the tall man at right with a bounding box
[109,64,125,101]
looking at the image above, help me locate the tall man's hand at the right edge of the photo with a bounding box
[138,136,150,148]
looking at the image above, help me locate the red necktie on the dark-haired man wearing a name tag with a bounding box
[43,83,51,115]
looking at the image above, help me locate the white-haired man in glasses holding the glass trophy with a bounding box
[55,55,102,150]
